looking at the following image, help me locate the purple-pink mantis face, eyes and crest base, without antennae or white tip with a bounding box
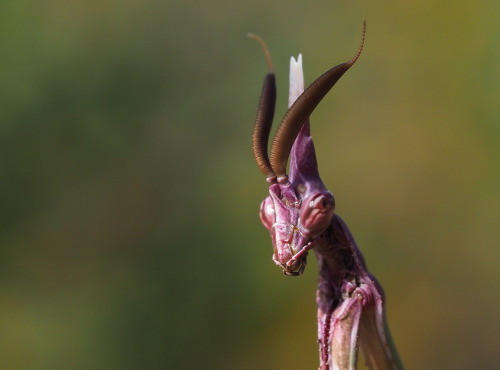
[260,129,335,276]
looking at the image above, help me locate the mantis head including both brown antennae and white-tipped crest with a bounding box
[249,25,366,276]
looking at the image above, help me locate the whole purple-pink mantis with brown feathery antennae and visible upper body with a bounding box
[249,22,403,370]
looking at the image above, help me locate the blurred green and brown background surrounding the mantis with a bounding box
[0,0,500,369]
